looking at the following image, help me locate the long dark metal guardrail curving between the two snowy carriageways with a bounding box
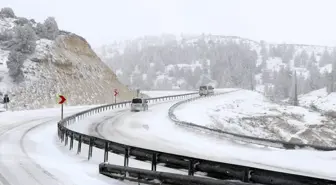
[58,93,336,185]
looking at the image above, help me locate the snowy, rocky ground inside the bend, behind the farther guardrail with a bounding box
[175,90,336,146]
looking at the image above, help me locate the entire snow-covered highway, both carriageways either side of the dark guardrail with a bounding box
[0,91,336,185]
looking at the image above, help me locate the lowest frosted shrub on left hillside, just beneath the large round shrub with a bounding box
[7,50,27,82]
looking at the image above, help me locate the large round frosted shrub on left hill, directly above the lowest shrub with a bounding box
[12,24,37,54]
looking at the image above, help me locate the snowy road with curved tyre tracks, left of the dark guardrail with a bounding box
[0,106,134,185]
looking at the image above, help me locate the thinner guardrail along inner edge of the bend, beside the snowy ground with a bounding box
[168,91,336,151]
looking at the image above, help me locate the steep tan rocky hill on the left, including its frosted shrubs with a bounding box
[0,8,133,110]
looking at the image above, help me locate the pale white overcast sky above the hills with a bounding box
[0,0,336,47]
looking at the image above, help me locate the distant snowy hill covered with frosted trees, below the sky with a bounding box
[95,34,336,99]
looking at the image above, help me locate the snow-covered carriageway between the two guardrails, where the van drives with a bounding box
[71,95,336,179]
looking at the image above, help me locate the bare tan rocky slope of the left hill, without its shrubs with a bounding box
[0,7,134,110]
